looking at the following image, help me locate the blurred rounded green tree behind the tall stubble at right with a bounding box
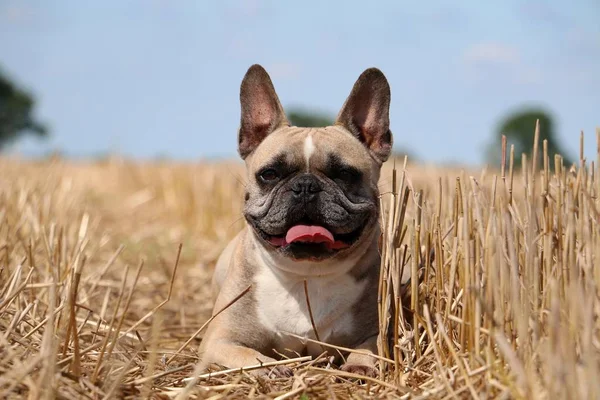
[487,108,571,168]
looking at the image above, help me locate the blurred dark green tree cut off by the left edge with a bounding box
[0,71,48,151]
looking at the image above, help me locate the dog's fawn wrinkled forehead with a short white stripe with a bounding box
[249,126,373,171]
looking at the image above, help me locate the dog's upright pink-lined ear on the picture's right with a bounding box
[335,68,393,163]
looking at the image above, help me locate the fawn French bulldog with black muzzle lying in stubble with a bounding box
[200,65,408,376]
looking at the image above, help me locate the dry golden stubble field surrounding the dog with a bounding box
[0,129,600,399]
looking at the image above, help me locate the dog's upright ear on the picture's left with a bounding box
[238,64,289,159]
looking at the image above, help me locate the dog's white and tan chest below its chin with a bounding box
[255,268,366,351]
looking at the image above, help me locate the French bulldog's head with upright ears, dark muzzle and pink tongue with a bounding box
[238,65,392,262]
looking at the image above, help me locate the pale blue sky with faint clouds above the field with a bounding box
[0,0,600,164]
